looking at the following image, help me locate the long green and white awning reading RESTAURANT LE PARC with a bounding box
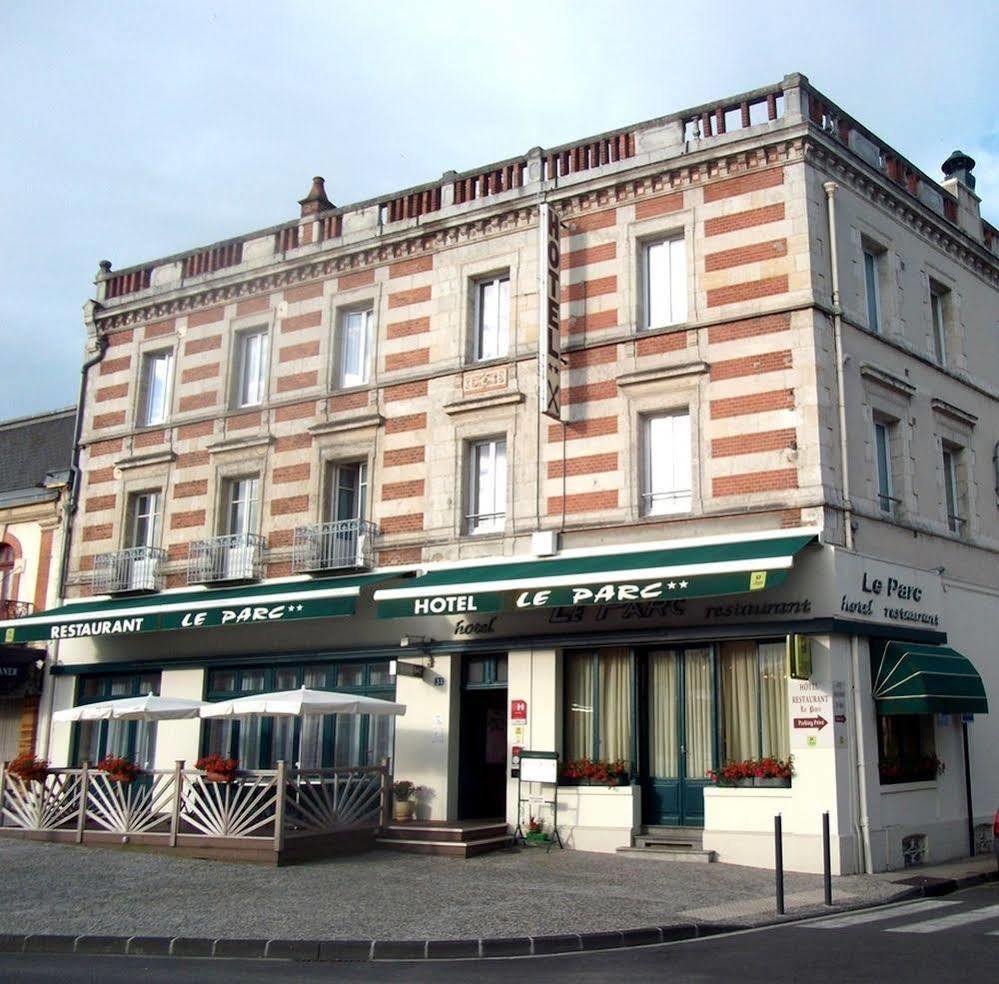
[0,570,409,643]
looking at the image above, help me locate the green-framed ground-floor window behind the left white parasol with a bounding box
[72,673,160,769]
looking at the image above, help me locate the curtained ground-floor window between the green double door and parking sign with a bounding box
[719,640,791,762]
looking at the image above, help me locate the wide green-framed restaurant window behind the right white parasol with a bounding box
[201,662,395,769]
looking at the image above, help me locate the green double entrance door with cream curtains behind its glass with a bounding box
[641,647,716,826]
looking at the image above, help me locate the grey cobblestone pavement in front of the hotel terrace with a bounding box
[0,840,907,940]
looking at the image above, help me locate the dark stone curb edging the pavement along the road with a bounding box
[0,871,999,962]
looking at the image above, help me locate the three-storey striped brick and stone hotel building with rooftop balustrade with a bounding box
[3,75,999,872]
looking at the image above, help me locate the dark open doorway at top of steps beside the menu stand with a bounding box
[458,655,507,820]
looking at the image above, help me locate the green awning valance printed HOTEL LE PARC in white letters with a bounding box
[378,570,787,618]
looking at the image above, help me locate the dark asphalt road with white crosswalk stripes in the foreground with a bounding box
[0,883,999,984]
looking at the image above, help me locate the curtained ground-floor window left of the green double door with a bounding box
[565,648,634,768]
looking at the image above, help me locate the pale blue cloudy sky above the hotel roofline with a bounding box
[0,0,999,420]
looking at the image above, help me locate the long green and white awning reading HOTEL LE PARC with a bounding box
[374,529,816,618]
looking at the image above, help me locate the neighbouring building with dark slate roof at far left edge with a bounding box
[0,407,76,762]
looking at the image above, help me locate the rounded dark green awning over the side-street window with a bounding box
[874,642,989,714]
